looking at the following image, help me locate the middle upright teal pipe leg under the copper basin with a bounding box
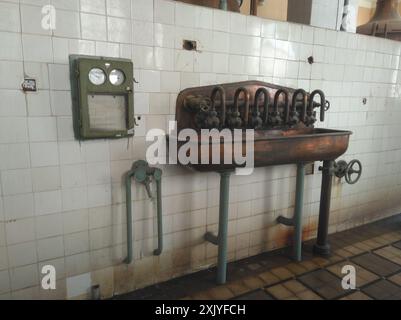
[294,163,305,261]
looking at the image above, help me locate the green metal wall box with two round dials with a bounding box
[70,55,136,140]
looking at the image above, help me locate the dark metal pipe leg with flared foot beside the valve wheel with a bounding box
[313,160,334,256]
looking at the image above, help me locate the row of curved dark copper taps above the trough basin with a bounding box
[208,86,328,129]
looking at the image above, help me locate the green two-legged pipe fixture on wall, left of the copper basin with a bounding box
[124,160,163,264]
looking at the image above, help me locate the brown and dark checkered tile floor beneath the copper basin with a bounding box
[115,215,401,300]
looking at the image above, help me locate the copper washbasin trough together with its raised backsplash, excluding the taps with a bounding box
[170,81,352,172]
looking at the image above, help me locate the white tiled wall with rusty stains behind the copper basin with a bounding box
[0,0,401,298]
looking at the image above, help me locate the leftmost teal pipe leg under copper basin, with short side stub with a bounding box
[205,171,232,284]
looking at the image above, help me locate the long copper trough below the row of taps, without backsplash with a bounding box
[172,128,352,172]
